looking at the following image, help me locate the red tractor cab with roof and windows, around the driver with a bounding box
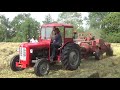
[39,23,74,62]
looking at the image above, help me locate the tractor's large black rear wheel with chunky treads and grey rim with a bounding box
[61,43,81,70]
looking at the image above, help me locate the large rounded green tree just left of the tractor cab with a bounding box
[11,13,40,42]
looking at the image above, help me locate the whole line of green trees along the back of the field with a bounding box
[0,12,120,43]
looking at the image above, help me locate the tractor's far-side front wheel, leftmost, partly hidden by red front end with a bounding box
[10,55,24,71]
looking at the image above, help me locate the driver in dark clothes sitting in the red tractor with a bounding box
[50,28,62,62]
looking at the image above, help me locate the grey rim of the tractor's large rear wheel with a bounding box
[69,50,79,66]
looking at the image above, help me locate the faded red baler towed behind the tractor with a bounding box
[75,33,111,58]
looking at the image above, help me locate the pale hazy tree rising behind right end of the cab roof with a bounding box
[57,12,83,31]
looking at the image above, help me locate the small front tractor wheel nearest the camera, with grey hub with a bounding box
[34,58,50,76]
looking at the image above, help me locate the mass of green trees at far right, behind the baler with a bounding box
[85,12,120,43]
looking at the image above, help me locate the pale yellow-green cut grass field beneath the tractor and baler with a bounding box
[0,42,120,78]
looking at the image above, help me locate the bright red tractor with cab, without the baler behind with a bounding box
[10,23,81,76]
